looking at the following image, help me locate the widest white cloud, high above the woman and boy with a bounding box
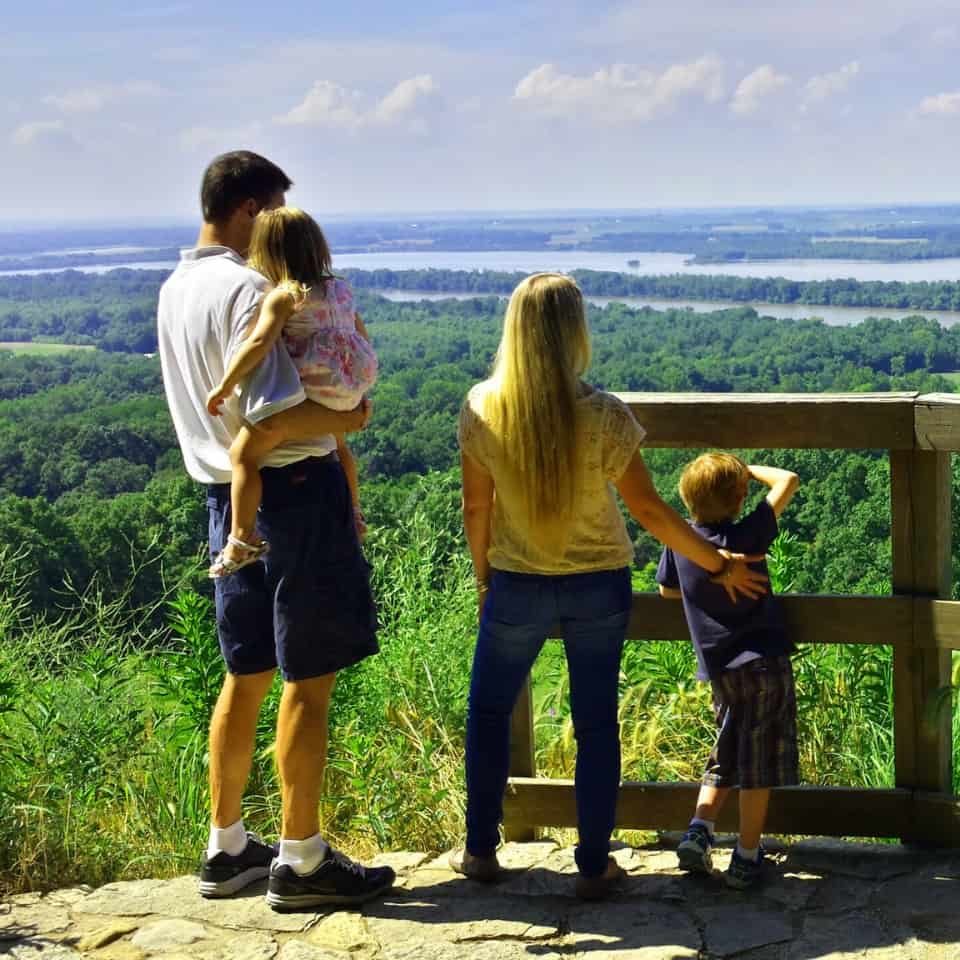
[513,57,724,120]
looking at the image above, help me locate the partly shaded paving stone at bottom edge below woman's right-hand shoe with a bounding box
[564,903,701,960]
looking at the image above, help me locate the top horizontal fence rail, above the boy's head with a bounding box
[618,393,920,450]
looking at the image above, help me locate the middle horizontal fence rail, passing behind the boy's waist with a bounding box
[627,593,912,645]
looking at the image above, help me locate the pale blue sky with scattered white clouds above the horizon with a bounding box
[0,0,960,221]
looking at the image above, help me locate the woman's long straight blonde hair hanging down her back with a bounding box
[484,273,590,550]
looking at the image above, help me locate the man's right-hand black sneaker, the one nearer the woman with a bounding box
[267,847,396,910]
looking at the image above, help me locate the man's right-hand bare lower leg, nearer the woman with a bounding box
[277,673,337,840]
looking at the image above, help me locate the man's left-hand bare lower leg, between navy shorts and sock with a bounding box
[210,670,274,828]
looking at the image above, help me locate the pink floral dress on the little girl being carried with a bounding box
[283,277,377,410]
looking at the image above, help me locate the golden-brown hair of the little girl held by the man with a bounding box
[247,207,333,296]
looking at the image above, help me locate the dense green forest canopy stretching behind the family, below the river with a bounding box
[0,282,960,607]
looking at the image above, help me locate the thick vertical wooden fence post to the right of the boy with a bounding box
[890,450,953,843]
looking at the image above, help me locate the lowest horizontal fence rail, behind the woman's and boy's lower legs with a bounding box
[504,778,916,837]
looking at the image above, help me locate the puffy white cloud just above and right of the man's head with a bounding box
[274,73,437,130]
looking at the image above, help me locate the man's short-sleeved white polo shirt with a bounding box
[157,247,336,483]
